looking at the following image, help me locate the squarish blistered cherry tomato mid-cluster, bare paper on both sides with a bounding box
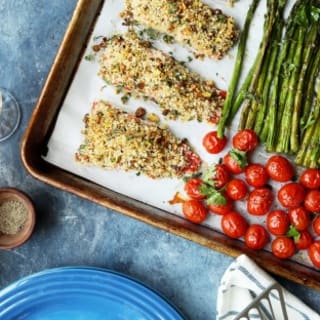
[247,188,273,216]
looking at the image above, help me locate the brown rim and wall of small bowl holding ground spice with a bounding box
[0,188,36,249]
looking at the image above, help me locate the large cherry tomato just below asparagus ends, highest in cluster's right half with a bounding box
[266,156,294,182]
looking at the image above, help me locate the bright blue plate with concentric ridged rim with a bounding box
[0,267,183,320]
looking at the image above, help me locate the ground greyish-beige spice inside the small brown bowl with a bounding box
[0,199,28,234]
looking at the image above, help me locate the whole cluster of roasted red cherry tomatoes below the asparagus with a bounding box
[182,129,320,268]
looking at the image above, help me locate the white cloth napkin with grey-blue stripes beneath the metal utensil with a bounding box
[217,255,320,320]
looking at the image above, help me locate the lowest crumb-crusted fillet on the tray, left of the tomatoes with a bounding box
[75,101,201,179]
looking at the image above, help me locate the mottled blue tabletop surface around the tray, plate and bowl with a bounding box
[0,0,320,320]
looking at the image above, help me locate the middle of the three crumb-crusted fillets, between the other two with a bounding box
[99,31,225,123]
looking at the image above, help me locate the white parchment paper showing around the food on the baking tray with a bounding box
[44,0,310,265]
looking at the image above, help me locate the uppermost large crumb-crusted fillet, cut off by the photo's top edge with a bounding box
[121,0,239,59]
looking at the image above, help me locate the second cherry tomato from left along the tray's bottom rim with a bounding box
[221,211,247,239]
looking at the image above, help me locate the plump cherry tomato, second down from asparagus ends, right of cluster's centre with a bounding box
[278,182,305,208]
